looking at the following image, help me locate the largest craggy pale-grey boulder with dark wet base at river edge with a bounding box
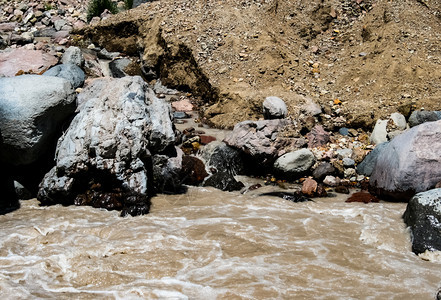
[38,76,175,215]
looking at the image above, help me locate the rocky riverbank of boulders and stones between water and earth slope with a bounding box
[0,0,441,253]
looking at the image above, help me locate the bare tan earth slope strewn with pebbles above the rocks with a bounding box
[83,0,441,128]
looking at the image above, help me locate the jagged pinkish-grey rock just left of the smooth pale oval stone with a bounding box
[224,119,291,168]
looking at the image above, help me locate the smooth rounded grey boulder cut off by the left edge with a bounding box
[0,75,76,166]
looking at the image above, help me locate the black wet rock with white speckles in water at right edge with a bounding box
[403,189,441,254]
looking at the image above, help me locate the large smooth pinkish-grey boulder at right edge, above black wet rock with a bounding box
[370,121,441,201]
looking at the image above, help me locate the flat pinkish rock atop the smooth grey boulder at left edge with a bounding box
[0,49,58,77]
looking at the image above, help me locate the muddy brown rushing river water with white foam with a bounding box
[0,188,441,299]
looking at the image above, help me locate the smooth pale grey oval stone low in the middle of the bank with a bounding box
[274,149,315,179]
